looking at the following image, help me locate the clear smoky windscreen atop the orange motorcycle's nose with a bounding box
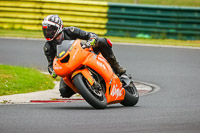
[56,40,75,58]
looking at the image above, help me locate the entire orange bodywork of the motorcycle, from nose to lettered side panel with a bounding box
[53,40,125,107]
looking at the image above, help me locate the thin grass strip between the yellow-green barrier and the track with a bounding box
[0,29,200,47]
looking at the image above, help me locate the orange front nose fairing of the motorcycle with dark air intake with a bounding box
[53,40,89,77]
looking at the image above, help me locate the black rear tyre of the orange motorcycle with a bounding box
[121,81,139,106]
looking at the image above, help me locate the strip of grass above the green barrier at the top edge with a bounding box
[79,0,200,7]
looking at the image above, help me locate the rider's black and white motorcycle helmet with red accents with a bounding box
[42,15,63,41]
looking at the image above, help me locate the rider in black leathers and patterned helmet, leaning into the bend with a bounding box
[42,15,126,98]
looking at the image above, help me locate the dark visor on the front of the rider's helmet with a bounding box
[42,25,58,40]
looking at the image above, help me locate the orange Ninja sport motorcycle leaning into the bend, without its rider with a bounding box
[53,40,139,109]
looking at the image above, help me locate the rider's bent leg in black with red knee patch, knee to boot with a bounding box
[96,38,126,75]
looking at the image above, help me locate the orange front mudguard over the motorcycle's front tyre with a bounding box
[71,68,95,86]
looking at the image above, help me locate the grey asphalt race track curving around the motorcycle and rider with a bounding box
[0,39,200,133]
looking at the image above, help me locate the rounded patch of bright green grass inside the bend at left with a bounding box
[0,65,54,96]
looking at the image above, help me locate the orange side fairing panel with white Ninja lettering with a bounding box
[84,54,125,104]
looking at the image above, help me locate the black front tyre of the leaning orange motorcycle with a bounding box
[73,74,107,109]
